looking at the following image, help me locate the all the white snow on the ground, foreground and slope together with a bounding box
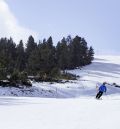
[0,56,120,129]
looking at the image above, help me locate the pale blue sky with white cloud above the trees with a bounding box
[0,0,120,55]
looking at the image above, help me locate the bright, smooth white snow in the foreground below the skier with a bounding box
[0,97,120,129]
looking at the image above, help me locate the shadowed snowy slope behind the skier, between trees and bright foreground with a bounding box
[0,56,120,98]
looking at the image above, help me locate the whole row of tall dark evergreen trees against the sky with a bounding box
[0,36,94,80]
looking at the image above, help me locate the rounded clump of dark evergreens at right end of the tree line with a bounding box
[56,36,94,70]
